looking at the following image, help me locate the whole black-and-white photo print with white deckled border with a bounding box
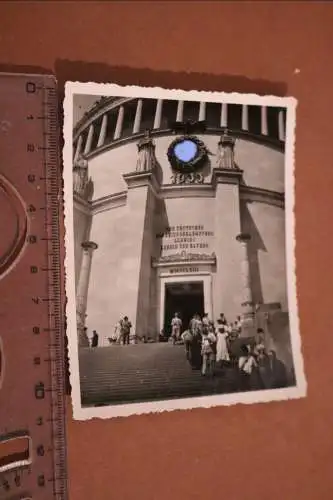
[64,82,306,419]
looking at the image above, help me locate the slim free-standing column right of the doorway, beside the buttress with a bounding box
[236,233,255,337]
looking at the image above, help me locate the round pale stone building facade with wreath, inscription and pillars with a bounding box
[73,97,291,370]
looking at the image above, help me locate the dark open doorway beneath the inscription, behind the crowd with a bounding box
[164,281,205,337]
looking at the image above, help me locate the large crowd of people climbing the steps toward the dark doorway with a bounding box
[170,313,287,391]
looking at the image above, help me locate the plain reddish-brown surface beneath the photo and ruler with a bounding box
[0,2,333,500]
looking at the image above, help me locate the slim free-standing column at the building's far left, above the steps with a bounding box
[76,241,98,347]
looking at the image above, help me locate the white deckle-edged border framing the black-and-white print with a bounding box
[63,82,307,420]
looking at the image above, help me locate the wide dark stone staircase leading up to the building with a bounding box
[79,343,237,406]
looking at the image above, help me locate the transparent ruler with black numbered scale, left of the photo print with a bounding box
[0,73,67,500]
